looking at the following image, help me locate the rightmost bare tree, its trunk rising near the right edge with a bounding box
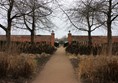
[95,0,118,56]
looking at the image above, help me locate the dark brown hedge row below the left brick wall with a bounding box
[0,41,56,54]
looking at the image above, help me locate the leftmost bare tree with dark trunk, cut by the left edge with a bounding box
[0,0,24,44]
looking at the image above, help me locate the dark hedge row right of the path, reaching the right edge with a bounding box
[66,42,118,55]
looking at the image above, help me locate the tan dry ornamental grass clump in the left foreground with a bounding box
[0,54,37,78]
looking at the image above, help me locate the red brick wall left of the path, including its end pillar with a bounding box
[0,31,55,46]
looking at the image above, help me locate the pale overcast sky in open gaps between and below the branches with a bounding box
[0,0,118,38]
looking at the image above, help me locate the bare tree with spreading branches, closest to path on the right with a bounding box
[56,0,104,51]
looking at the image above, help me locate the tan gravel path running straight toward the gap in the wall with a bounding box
[33,47,78,83]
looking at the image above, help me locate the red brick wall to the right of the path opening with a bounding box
[68,31,118,45]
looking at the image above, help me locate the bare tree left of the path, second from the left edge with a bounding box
[16,0,54,43]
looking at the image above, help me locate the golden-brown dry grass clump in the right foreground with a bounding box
[78,56,118,83]
